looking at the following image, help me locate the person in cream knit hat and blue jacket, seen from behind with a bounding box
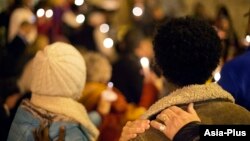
[8,42,99,141]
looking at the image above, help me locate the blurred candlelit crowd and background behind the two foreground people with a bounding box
[0,0,250,141]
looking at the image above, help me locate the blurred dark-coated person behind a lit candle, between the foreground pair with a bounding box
[111,29,158,108]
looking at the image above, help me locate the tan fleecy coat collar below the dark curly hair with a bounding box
[142,83,234,119]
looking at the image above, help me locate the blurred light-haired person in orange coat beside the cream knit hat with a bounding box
[79,51,145,141]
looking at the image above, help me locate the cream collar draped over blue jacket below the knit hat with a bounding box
[31,94,99,141]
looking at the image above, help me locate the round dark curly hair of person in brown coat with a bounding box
[153,17,221,86]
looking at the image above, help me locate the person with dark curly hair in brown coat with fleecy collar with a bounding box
[120,17,250,141]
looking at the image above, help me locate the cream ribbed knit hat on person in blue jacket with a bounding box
[31,42,86,99]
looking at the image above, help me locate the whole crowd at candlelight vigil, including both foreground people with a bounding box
[0,0,250,141]
